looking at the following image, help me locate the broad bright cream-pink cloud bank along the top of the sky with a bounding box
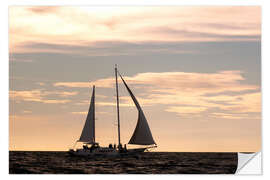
[9,7,261,53]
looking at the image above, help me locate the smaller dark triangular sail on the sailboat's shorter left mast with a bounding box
[78,86,95,144]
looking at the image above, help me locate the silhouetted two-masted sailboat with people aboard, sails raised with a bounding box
[68,65,157,156]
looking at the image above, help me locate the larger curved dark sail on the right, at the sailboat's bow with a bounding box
[118,72,156,145]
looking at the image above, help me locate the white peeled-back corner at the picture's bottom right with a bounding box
[235,152,262,174]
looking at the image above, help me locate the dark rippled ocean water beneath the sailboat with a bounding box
[9,151,237,174]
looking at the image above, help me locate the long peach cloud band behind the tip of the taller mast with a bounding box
[53,71,255,90]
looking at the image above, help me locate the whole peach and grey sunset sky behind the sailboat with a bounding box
[9,6,261,152]
